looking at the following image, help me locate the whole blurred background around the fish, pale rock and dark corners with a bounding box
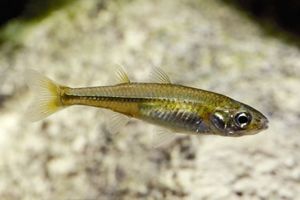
[0,0,300,200]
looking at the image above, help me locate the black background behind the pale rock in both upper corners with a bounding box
[0,0,300,37]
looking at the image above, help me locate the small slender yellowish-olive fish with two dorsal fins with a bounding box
[25,68,268,137]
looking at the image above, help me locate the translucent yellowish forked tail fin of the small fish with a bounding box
[25,70,63,121]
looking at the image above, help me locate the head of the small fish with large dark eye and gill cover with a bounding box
[210,103,268,137]
